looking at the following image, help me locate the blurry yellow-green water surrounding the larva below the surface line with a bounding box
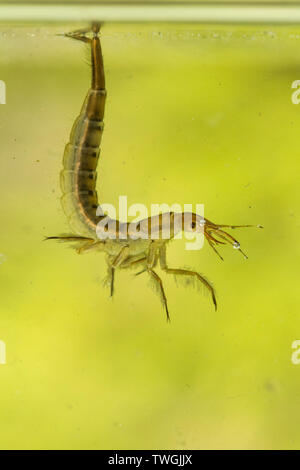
[0,24,300,449]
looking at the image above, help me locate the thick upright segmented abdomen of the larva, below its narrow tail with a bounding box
[60,89,106,238]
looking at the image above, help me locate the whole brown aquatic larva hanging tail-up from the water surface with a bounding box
[48,25,260,320]
